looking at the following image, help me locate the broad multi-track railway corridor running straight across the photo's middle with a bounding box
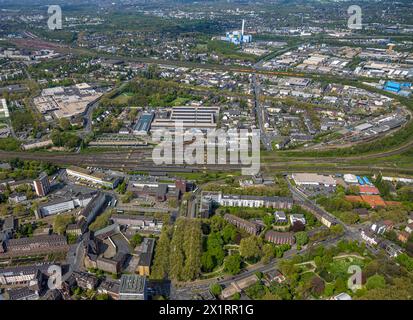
[0,150,413,175]
